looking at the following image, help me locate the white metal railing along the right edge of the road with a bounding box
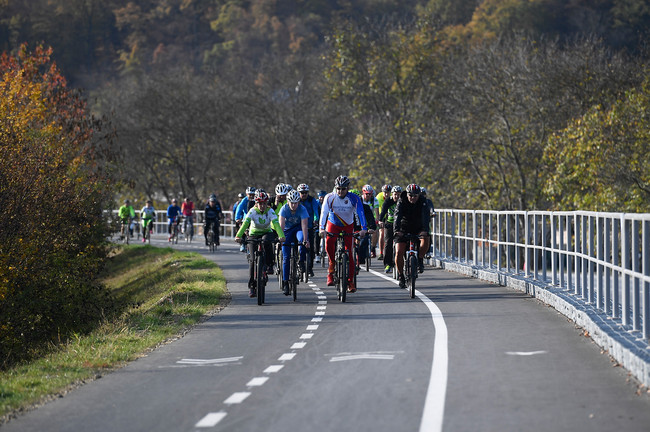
[432,209,650,342]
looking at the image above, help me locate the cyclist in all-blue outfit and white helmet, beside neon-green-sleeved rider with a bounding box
[278,190,310,295]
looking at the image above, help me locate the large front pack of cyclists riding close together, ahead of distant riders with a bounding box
[234,176,435,297]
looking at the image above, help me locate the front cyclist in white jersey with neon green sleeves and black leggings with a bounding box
[235,189,284,297]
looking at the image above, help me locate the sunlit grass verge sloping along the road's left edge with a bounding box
[0,246,229,424]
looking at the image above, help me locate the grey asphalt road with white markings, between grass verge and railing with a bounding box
[2,241,650,432]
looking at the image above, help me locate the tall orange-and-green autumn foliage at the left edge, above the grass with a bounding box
[0,46,112,367]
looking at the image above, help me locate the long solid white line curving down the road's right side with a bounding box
[370,270,449,432]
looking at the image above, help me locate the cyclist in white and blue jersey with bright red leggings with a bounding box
[319,175,367,292]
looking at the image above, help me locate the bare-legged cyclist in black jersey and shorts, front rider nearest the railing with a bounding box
[394,183,431,288]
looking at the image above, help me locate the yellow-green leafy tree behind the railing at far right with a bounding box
[544,69,650,213]
